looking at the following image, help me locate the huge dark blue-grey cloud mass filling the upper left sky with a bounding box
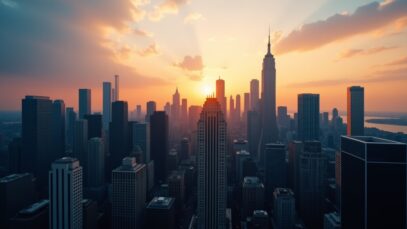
[0,0,169,90]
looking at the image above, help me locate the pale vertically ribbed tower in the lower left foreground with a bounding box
[49,157,83,229]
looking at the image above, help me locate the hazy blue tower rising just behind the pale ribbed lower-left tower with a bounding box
[72,119,88,167]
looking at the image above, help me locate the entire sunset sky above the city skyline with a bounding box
[0,0,407,112]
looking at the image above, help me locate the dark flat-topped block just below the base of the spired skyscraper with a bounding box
[264,143,287,202]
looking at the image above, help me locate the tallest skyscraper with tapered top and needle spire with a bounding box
[261,31,278,151]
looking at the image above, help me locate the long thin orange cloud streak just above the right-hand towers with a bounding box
[286,68,407,88]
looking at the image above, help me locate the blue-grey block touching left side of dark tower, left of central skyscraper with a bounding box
[131,122,150,163]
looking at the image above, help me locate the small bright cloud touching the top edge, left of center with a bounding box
[148,0,188,21]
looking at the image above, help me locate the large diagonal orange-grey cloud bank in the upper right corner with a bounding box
[275,0,407,54]
